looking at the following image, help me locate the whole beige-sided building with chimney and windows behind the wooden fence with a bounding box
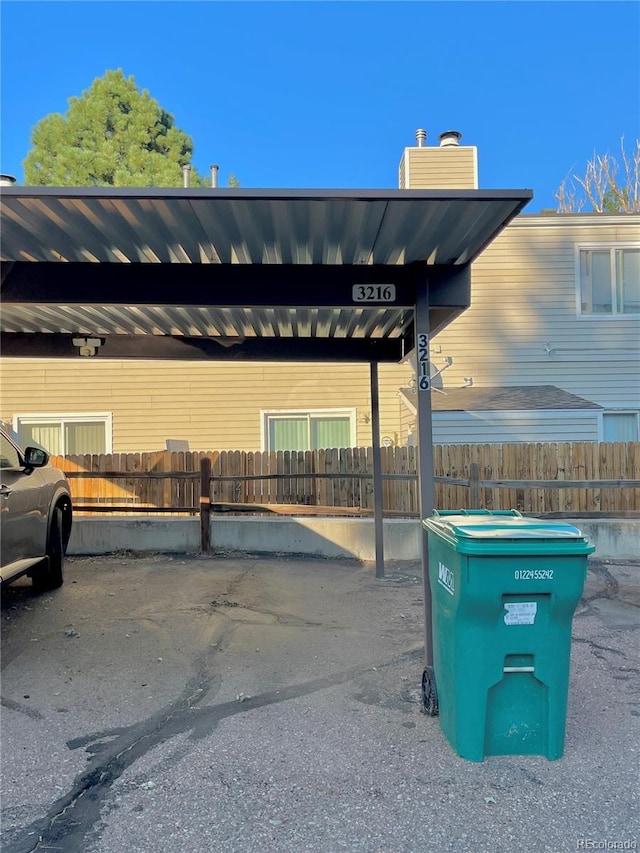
[0,132,640,453]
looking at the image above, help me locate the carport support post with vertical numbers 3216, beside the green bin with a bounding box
[414,281,435,667]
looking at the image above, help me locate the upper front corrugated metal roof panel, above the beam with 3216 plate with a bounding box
[1,187,531,265]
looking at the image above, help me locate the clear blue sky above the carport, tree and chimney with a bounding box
[0,0,640,212]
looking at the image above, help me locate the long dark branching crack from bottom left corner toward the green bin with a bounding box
[3,646,423,853]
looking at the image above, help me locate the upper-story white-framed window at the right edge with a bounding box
[579,246,640,315]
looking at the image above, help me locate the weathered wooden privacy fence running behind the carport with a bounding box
[52,442,640,518]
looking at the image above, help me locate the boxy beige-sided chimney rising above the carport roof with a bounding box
[399,145,478,190]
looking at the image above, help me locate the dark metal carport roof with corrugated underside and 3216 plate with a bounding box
[0,187,532,361]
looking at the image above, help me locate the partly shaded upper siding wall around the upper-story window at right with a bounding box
[433,214,640,408]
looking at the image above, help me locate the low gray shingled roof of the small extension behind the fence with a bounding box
[402,385,602,412]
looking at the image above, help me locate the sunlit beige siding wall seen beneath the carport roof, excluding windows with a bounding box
[0,358,410,453]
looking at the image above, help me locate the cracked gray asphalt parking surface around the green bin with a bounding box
[1,554,640,853]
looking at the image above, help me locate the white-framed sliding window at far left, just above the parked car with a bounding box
[13,412,112,456]
